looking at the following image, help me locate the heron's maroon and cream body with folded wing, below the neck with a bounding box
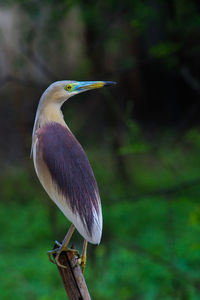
[33,122,102,244]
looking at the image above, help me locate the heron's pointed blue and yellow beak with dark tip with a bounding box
[73,81,116,92]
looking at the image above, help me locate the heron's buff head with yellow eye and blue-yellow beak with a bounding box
[43,80,116,104]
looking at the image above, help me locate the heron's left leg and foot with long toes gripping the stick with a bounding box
[48,224,78,268]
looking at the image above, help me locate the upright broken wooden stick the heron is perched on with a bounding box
[54,245,91,300]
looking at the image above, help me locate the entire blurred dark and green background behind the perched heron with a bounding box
[0,0,200,300]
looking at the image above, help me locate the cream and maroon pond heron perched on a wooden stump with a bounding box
[31,80,116,271]
